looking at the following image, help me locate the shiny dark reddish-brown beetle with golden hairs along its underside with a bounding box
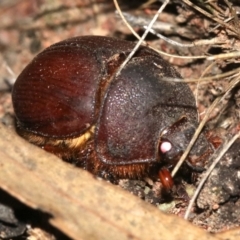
[12,36,209,181]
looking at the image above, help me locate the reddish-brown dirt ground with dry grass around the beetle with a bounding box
[0,0,240,239]
